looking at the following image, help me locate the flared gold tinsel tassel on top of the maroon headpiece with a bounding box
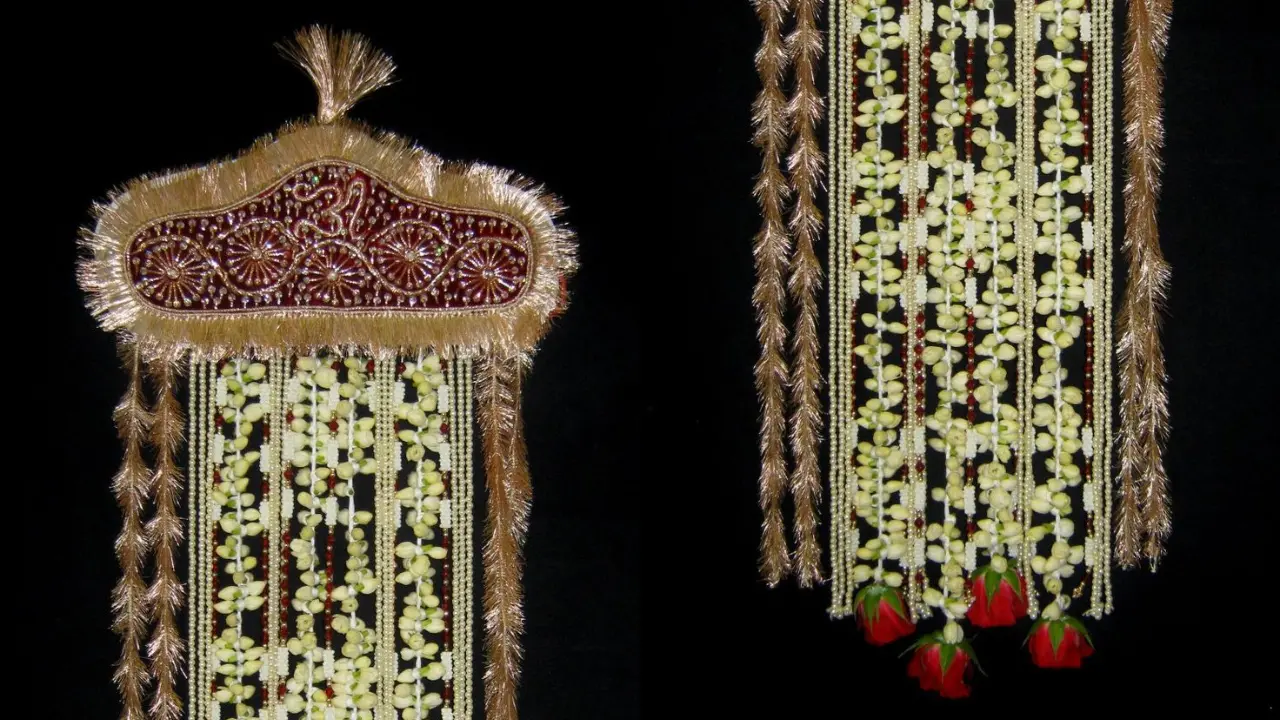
[279,26,396,123]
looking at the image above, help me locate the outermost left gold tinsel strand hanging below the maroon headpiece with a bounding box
[111,338,151,720]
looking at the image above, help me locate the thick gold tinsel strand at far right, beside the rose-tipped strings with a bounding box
[1116,0,1172,570]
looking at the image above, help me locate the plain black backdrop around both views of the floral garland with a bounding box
[24,0,1280,720]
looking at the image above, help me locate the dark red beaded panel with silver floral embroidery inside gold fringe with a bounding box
[128,160,531,313]
